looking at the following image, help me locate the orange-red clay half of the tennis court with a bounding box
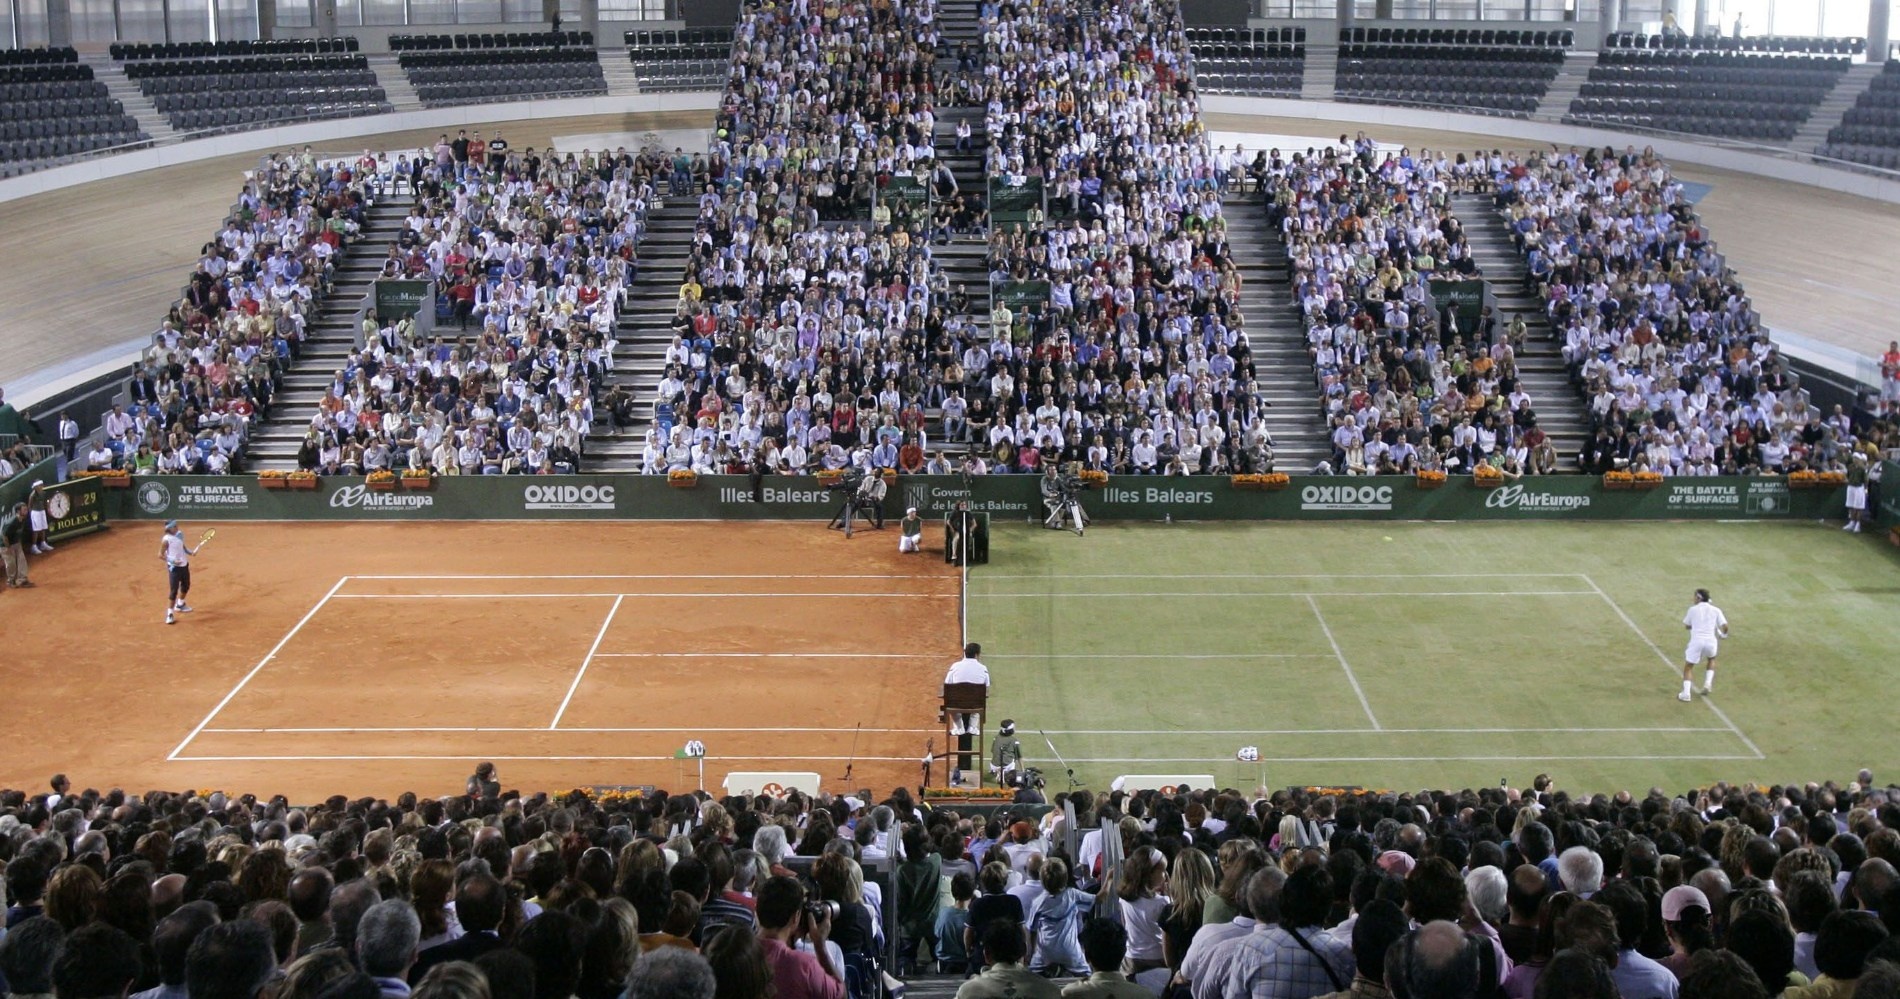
[0,522,961,801]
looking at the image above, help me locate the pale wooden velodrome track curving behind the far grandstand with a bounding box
[0,112,1900,395]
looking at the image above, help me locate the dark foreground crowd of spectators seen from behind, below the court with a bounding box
[0,763,1900,999]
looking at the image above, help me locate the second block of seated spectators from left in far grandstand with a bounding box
[277,133,672,475]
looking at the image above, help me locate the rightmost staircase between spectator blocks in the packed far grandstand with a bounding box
[1452,194,1590,471]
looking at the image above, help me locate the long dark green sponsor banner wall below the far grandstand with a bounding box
[106,475,1839,522]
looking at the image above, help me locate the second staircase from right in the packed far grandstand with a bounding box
[1222,200,1332,471]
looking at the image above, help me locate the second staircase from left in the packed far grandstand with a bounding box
[581,201,699,471]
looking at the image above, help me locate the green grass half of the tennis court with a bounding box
[967,522,1900,794]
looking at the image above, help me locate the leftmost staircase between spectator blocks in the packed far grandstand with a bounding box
[245,201,409,471]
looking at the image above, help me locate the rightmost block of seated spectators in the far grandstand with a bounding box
[1497,148,1879,475]
